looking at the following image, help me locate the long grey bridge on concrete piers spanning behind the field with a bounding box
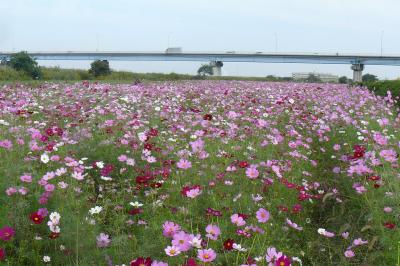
[0,51,400,82]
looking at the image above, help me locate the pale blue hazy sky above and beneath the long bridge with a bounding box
[0,0,400,79]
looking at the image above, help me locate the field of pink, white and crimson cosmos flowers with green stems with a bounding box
[0,81,400,266]
